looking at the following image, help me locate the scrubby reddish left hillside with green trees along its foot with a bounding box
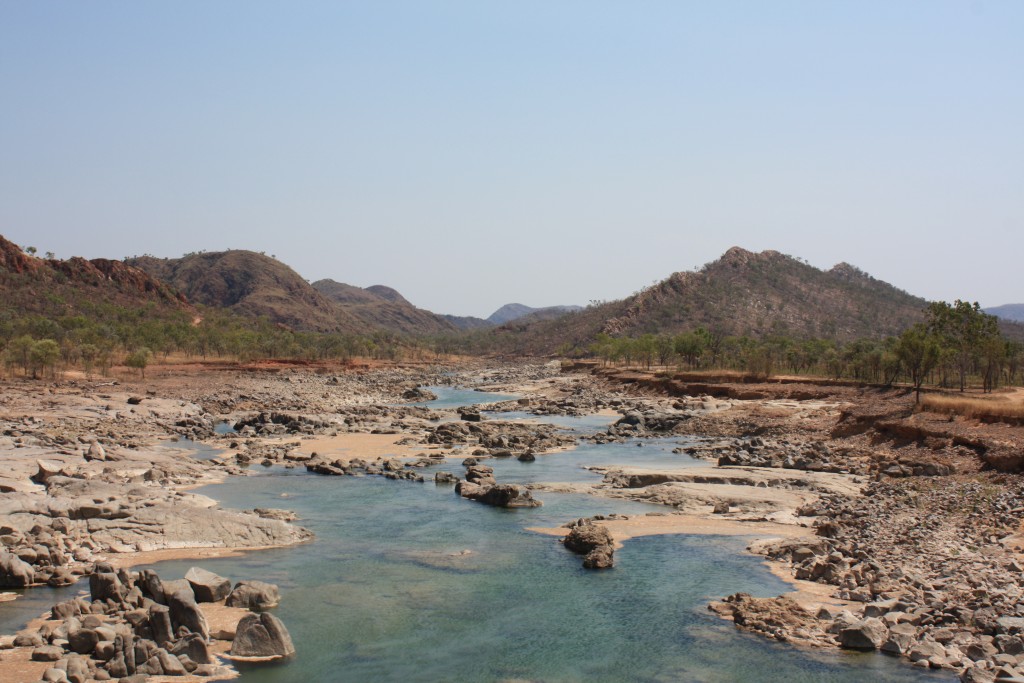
[0,237,436,377]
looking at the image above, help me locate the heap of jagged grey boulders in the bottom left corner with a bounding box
[11,562,295,683]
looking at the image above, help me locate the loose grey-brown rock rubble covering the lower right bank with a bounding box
[716,474,1024,681]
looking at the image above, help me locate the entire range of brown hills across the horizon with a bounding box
[6,232,1024,353]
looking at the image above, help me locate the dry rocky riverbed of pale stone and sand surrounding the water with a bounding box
[0,364,1024,683]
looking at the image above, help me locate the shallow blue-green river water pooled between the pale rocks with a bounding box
[0,389,953,683]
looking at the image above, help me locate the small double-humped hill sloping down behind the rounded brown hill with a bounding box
[312,280,458,335]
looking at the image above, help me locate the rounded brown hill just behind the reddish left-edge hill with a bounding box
[128,250,366,333]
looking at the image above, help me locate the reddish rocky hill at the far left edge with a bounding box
[0,236,193,316]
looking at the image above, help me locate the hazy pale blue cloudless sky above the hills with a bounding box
[0,0,1024,315]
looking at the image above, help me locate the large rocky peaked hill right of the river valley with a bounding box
[498,247,927,353]
